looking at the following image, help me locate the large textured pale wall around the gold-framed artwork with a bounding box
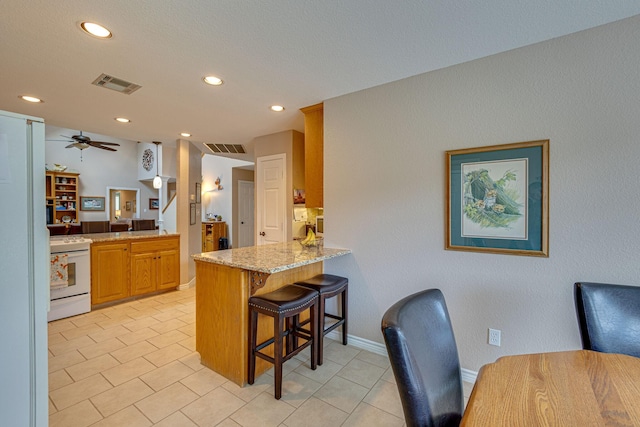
[324,17,640,370]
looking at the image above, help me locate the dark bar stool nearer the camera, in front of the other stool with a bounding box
[248,285,318,399]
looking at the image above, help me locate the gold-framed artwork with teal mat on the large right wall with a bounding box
[445,140,549,257]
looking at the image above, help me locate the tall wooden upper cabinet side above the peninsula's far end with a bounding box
[300,103,324,208]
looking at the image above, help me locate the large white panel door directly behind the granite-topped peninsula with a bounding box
[256,153,287,245]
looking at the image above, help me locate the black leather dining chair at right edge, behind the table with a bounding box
[574,282,640,357]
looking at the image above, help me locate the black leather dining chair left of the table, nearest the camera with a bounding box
[382,289,464,427]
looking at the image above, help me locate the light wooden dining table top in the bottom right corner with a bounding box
[460,350,640,427]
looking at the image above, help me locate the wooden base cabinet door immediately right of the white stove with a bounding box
[91,243,129,304]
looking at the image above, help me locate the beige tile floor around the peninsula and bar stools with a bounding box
[49,289,471,427]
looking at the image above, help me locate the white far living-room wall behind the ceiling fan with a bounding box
[45,124,158,221]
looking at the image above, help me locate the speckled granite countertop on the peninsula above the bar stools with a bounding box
[191,241,351,274]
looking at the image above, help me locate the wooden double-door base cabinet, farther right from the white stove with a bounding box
[131,237,180,296]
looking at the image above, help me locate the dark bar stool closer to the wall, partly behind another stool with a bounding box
[296,274,349,365]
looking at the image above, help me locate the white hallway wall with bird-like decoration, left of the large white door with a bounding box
[201,154,253,246]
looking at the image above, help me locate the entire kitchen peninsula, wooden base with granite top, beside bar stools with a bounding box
[192,241,351,387]
